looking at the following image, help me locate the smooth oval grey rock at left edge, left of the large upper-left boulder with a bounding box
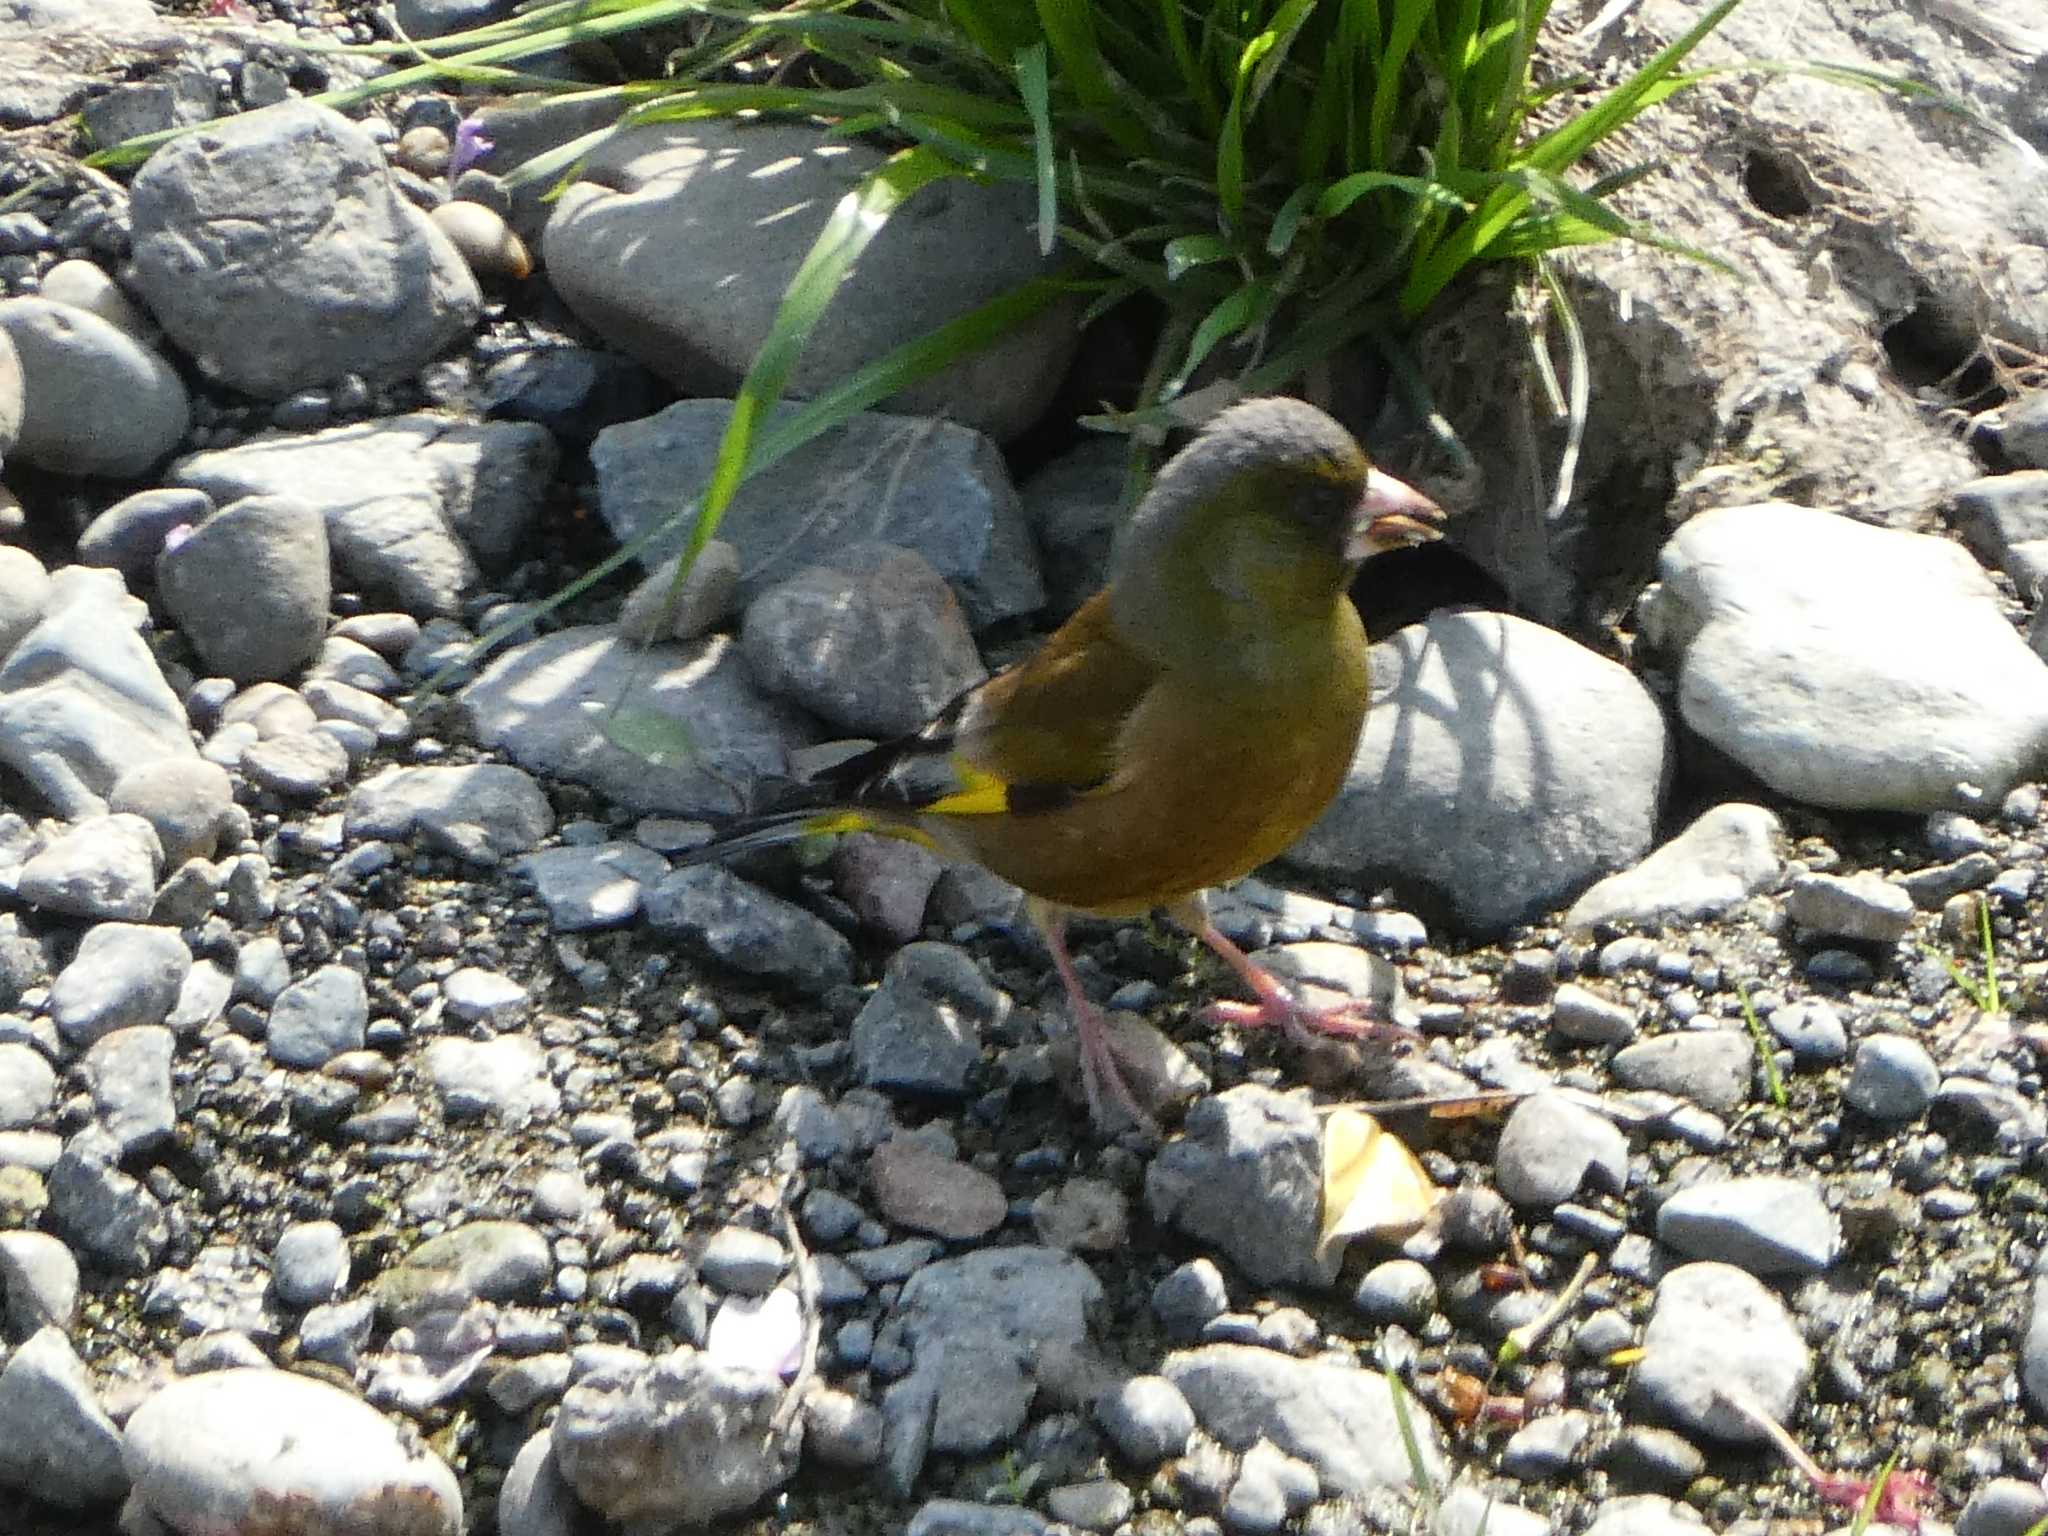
[0,299,190,477]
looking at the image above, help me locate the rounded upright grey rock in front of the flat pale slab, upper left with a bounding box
[156,496,328,682]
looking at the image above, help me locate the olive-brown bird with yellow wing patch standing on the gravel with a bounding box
[690,395,1444,1130]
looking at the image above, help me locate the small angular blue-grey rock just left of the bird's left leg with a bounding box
[852,944,1010,1096]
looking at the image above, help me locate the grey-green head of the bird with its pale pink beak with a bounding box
[1114,395,1444,634]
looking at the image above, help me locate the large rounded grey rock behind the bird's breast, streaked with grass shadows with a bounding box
[1288,612,1665,932]
